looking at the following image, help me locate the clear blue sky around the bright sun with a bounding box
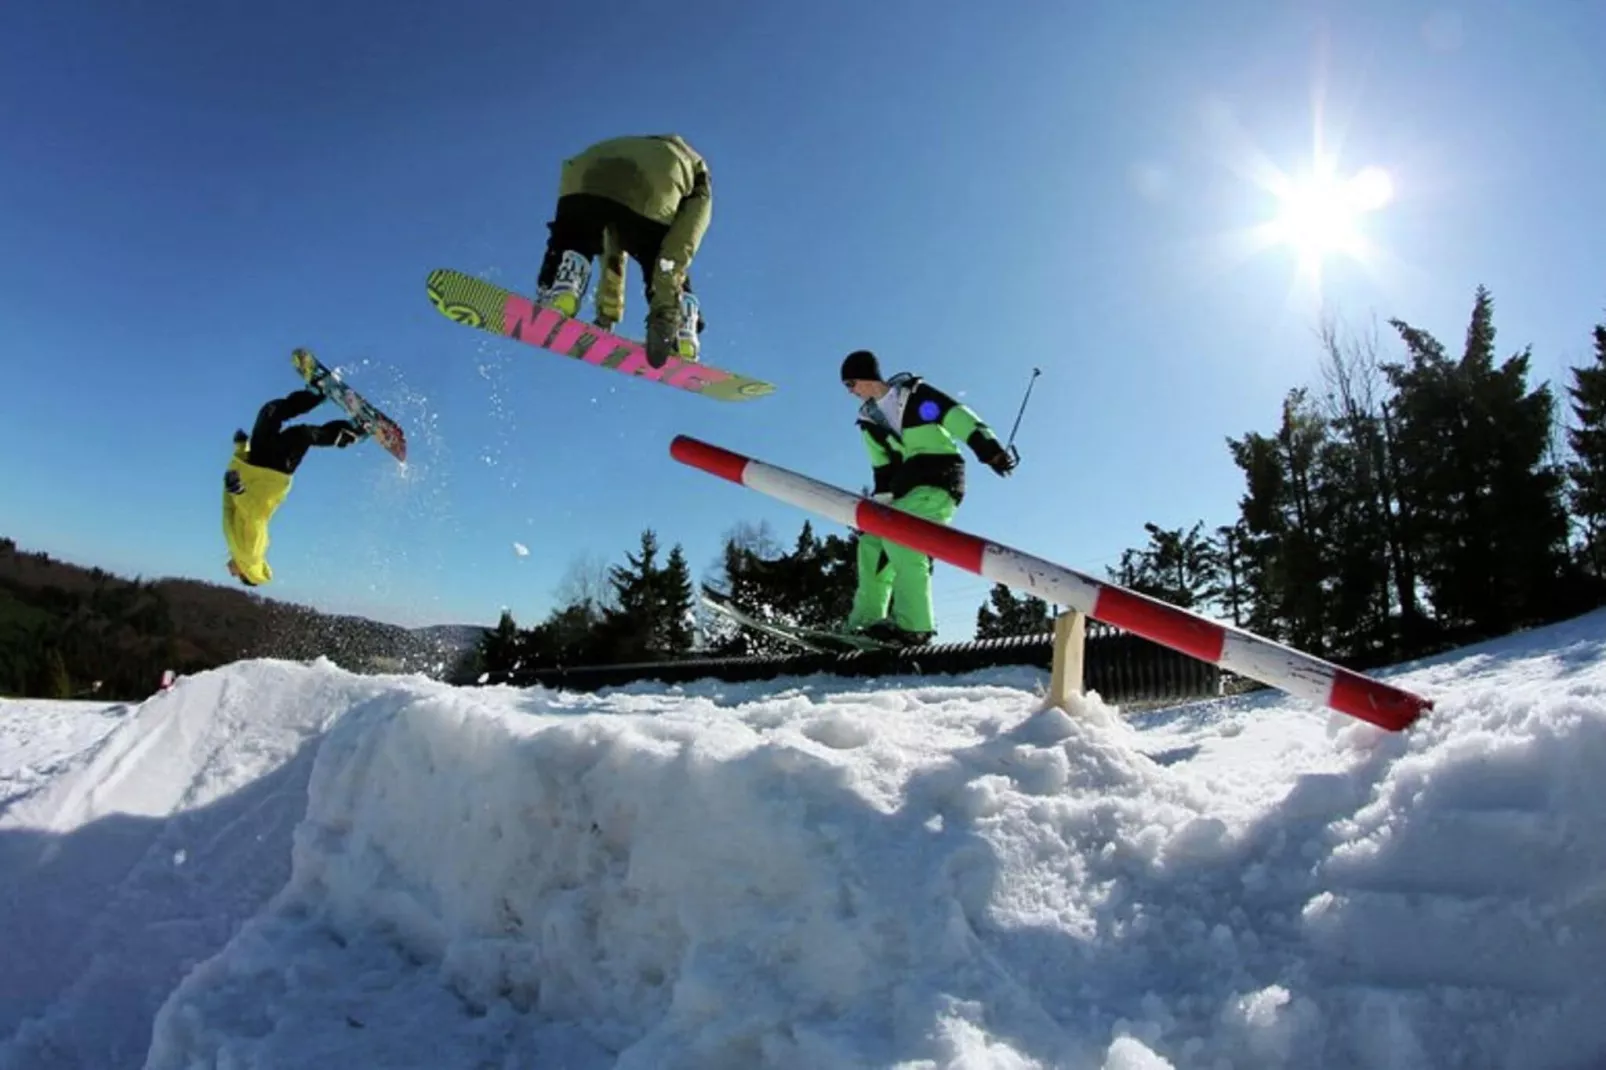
[0,0,1606,638]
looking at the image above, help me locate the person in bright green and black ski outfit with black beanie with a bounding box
[842,349,1015,646]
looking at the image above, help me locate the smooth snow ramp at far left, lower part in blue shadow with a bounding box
[0,662,423,1070]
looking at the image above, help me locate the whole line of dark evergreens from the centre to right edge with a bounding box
[472,288,1606,673]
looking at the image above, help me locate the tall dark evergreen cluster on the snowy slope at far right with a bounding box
[1108,288,1606,665]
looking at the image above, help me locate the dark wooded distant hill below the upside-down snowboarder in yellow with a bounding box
[0,538,485,699]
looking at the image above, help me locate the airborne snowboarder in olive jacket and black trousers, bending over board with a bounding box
[536,133,713,368]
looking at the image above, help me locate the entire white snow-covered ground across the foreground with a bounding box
[0,614,1606,1070]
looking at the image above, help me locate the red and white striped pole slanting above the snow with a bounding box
[670,435,1433,731]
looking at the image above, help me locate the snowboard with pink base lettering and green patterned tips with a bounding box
[426,268,776,402]
